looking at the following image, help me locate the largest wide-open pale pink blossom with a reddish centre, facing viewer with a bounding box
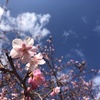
[10,37,37,63]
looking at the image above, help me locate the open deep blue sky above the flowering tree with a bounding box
[0,0,100,73]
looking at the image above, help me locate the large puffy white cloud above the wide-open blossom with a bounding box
[0,7,50,40]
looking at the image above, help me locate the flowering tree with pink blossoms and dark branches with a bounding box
[0,1,99,100]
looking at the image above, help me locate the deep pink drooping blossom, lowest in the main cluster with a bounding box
[28,69,45,89]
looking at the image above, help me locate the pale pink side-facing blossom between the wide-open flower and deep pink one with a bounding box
[26,53,45,71]
